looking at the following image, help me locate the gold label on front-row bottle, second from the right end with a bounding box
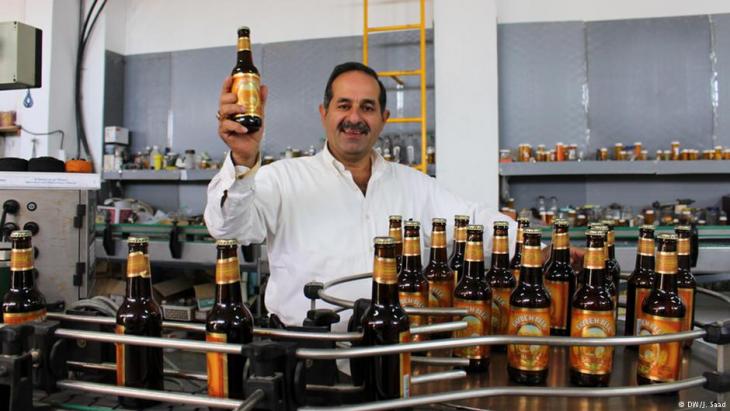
[570,308,616,375]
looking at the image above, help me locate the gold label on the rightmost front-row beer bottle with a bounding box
[637,314,682,382]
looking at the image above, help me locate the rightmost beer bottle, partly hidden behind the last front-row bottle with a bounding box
[674,225,697,348]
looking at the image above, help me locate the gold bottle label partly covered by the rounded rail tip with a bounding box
[454,297,492,359]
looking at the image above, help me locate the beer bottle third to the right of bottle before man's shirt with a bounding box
[423,218,454,339]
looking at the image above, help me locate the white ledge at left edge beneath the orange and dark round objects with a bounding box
[0,171,101,190]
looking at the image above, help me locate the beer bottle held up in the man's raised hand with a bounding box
[231,27,263,133]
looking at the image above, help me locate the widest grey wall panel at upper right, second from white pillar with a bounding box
[586,16,712,153]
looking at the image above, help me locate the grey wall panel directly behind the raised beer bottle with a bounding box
[170,44,263,160]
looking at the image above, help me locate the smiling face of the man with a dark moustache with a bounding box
[319,71,389,162]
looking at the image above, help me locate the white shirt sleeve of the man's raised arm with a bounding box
[204,155,281,245]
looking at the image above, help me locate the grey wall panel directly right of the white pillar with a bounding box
[498,22,586,148]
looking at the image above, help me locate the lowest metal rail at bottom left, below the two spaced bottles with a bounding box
[56,380,247,410]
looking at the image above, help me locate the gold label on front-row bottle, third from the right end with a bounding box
[507,306,550,371]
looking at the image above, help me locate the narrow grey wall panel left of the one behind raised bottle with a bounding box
[124,53,172,152]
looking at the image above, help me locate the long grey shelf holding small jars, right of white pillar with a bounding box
[499,160,730,177]
